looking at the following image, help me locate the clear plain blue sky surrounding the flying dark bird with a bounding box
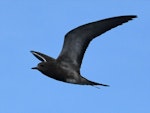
[0,0,150,113]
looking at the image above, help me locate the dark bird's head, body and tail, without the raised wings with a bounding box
[31,51,107,86]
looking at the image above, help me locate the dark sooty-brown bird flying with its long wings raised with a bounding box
[31,15,137,86]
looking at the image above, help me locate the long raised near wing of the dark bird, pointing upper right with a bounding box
[57,15,136,69]
